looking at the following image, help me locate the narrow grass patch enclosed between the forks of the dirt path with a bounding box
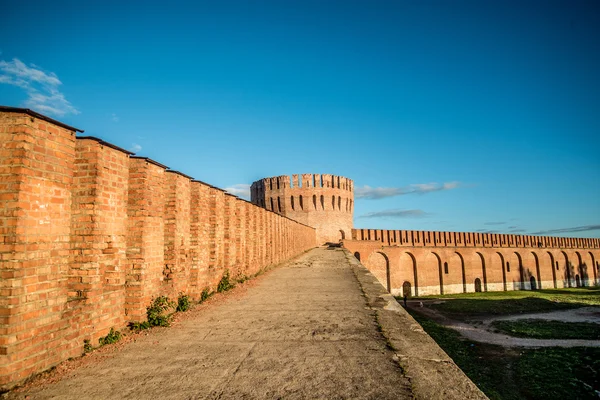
[492,319,600,340]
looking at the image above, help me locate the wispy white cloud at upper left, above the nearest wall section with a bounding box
[0,58,79,116]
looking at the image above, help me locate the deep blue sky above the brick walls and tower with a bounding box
[0,0,600,237]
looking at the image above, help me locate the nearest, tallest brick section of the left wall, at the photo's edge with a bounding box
[0,112,75,384]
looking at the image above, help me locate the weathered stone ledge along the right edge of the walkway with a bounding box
[344,250,487,400]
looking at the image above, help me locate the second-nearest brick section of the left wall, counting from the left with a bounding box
[68,139,129,352]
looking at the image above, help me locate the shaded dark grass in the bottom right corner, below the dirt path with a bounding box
[409,309,600,400]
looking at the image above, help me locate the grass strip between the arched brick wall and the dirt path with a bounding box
[414,287,600,317]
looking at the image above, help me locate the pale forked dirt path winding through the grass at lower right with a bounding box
[411,302,600,347]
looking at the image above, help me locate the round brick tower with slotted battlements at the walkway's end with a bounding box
[250,174,354,243]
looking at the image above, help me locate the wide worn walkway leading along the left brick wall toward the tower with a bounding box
[8,249,412,399]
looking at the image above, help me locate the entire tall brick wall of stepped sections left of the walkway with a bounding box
[0,107,316,388]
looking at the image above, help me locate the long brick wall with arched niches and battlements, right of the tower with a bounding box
[344,229,600,296]
